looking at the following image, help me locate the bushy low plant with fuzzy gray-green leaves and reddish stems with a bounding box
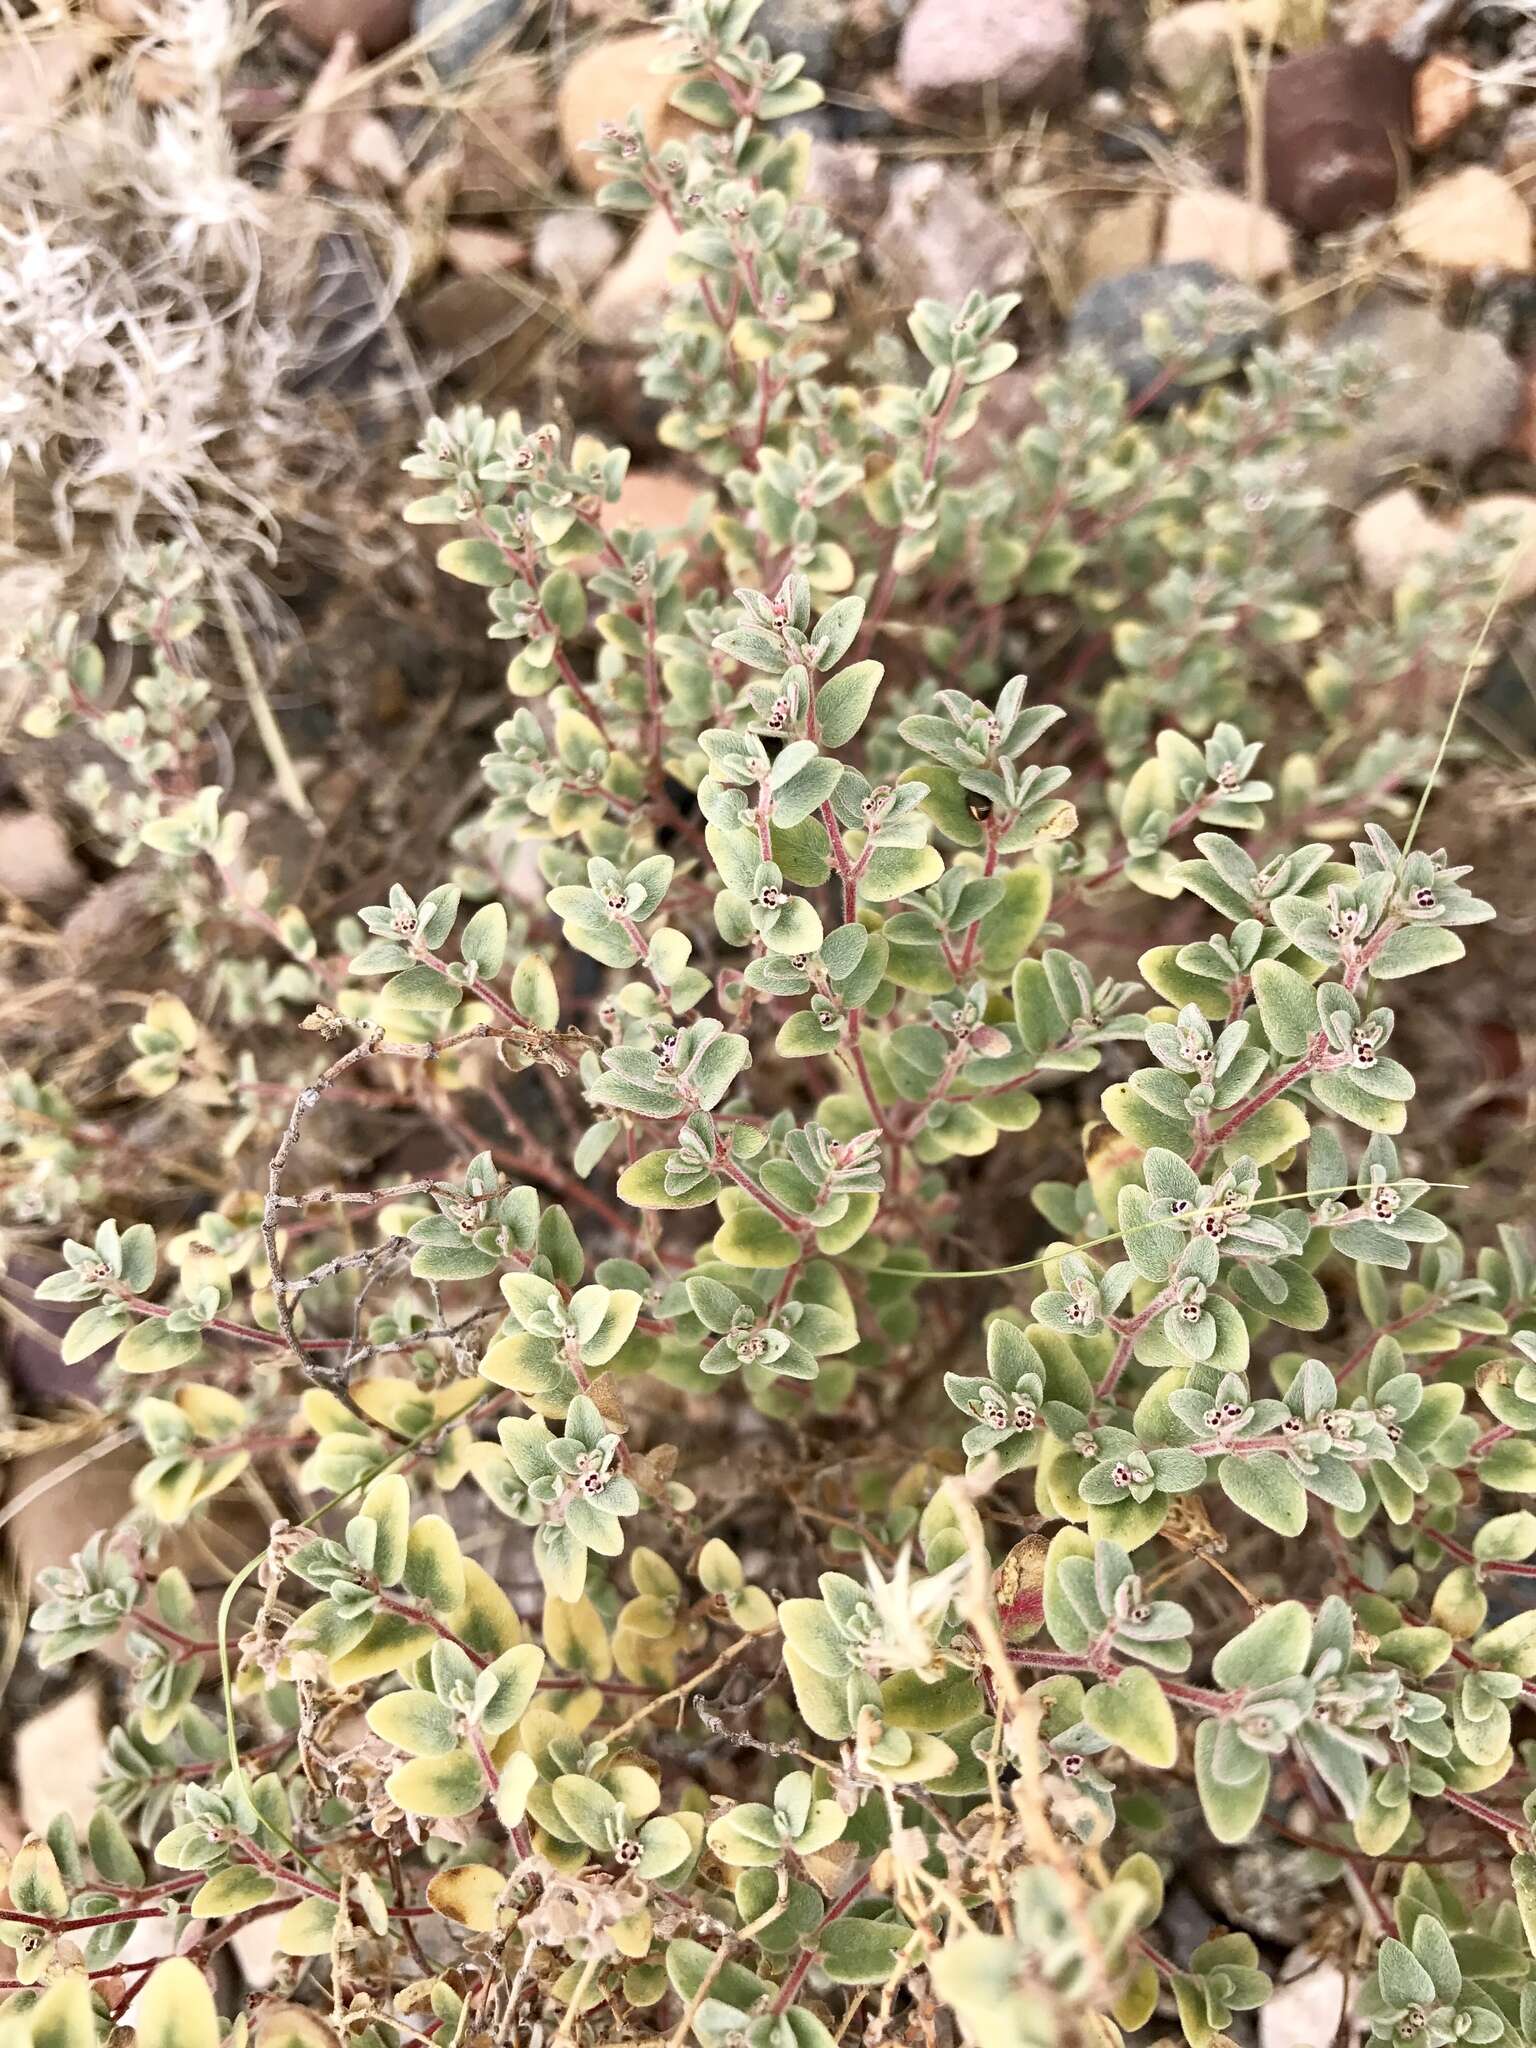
[0,0,1536,2048]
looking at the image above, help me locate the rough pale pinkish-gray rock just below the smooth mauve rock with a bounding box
[872,162,1034,303]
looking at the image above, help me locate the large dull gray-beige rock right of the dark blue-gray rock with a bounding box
[1321,299,1524,502]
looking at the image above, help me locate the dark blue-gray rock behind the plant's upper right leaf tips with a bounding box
[1067,262,1274,410]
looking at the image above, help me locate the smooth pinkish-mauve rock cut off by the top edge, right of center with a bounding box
[897,0,1087,113]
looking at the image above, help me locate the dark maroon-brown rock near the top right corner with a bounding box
[1253,43,1413,236]
